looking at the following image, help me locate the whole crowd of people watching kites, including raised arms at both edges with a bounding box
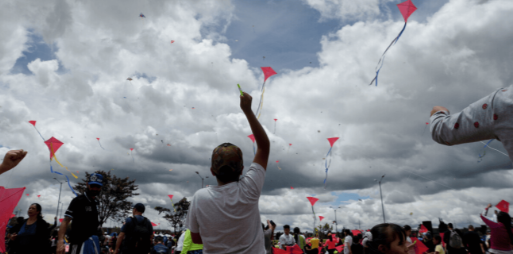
[0,89,513,254]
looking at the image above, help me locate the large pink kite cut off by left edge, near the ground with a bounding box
[0,186,25,253]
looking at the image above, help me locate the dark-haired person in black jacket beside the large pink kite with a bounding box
[11,203,50,254]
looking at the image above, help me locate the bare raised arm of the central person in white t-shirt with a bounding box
[240,93,271,169]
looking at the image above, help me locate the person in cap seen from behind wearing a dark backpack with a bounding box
[114,203,153,254]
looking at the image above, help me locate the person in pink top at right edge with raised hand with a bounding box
[481,204,513,254]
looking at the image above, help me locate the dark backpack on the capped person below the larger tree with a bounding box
[123,217,152,253]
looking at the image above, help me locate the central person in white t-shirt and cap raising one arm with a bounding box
[187,93,270,254]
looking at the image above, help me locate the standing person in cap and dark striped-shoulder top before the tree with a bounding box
[57,173,103,254]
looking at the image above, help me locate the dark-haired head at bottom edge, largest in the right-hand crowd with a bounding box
[367,223,408,254]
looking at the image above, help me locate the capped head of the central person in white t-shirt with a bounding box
[210,143,244,183]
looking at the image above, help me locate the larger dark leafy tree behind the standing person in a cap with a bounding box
[73,170,139,226]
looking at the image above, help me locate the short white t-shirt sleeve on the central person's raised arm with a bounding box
[239,163,265,202]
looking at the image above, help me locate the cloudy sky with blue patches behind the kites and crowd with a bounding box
[0,0,513,230]
